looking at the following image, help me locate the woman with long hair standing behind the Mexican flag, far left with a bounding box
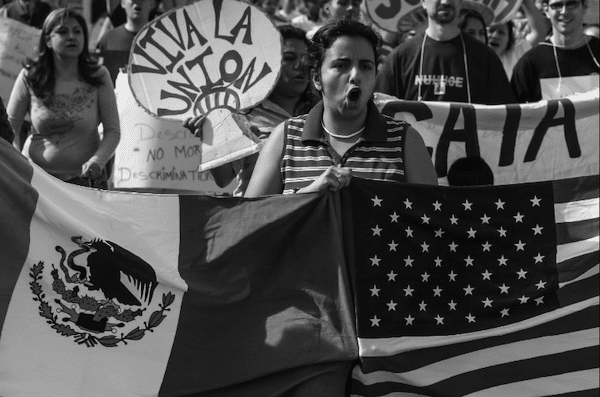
[7,8,120,188]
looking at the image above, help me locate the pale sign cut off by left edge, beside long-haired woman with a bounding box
[0,17,41,105]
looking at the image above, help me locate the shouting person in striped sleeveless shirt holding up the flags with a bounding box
[245,19,437,197]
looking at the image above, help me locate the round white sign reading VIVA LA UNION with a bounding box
[128,0,282,120]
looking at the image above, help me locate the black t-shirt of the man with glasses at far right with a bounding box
[511,37,600,102]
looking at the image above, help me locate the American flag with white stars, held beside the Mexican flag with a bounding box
[349,176,599,396]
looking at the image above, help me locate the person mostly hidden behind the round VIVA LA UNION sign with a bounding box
[183,25,316,196]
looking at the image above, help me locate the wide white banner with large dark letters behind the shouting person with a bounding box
[376,90,600,184]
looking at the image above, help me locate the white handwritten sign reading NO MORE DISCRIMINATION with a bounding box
[112,73,234,194]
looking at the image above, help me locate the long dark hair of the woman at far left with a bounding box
[25,7,102,104]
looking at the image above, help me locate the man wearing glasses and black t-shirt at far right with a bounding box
[511,0,600,102]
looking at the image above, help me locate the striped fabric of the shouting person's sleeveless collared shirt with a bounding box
[281,109,409,194]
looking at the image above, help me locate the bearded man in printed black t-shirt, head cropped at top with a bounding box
[375,0,515,105]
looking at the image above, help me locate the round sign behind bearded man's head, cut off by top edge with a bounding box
[366,0,522,33]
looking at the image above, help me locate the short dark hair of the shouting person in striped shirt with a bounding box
[308,18,382,76]
